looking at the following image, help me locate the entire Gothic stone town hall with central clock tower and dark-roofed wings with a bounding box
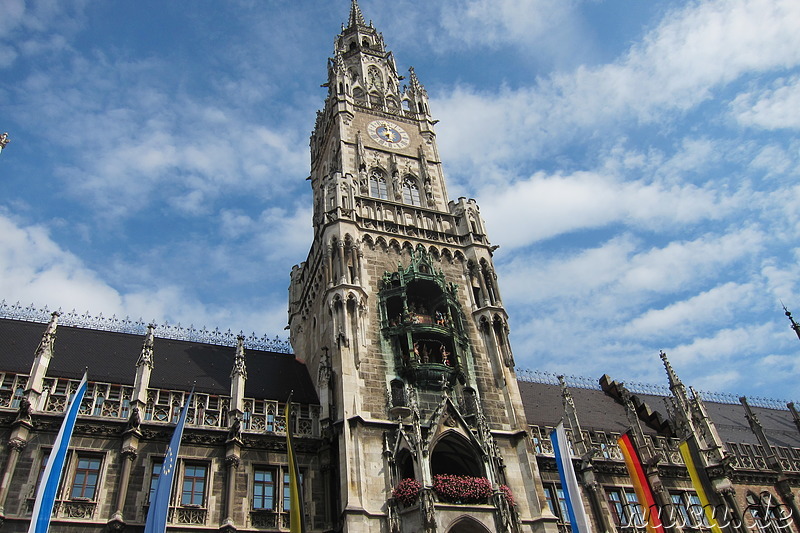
[0,0,800,533]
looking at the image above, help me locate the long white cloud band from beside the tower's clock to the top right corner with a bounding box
[433,0,800,172]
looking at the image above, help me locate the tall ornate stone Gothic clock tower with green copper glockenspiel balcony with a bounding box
[289,0,555,533]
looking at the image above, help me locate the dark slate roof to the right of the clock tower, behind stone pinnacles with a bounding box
[519,381,800,448]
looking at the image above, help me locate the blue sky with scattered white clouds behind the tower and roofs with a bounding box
[0,0,800,399]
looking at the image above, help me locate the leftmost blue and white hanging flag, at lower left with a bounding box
[28,372,87,533]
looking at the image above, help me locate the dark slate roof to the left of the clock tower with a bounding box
[0,319,319,404]
